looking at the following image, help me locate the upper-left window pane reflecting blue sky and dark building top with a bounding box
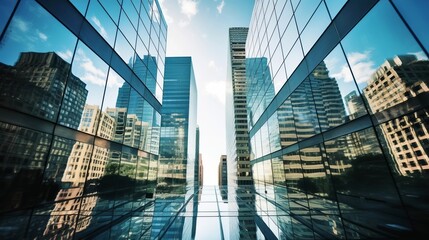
[0,1,76,121]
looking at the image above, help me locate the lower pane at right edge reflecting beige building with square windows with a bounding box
[377,107,429,232]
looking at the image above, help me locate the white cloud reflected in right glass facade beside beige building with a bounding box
[331,51,377,83]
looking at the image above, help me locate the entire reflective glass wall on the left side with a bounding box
[0,0,167,239]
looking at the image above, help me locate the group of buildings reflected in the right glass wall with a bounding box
[248,49,429,239]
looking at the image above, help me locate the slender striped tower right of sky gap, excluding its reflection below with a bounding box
[226,28,252,186]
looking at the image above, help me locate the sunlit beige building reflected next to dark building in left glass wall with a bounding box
[44,105,115,238]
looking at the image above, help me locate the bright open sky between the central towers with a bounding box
[160,0,254,185]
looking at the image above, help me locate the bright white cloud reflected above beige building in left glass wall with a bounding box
[77,49,106,86]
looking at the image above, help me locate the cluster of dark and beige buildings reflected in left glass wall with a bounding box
[0,53,164,238]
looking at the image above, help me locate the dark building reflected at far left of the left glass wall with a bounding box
[0,52,88,214]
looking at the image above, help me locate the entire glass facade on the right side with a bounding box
[246,0,429,239]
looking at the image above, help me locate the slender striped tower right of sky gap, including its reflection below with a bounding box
[226,27,256,239]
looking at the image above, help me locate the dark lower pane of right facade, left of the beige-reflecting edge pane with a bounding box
[325,128,410,234]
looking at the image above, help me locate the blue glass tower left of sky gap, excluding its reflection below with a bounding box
[158,57,198,187]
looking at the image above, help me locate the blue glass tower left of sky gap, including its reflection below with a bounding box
[152,57,199,239]
